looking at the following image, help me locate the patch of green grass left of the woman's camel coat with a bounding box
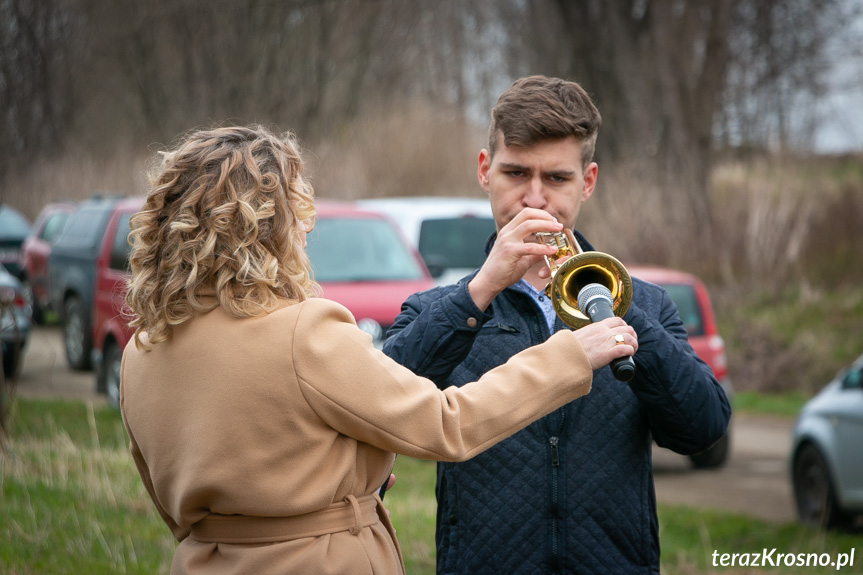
[0,400,174,575]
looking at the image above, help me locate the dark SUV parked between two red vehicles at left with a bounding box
[48,197,134,370]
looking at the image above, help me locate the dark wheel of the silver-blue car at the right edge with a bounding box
[792,443,843,529]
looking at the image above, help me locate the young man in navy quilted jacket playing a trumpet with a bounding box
[384,76,731,575]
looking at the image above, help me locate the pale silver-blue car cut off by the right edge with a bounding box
[790,355,863,528]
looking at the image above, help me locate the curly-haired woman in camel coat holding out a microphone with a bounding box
[120,126,637,574]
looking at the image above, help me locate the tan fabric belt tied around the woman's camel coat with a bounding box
[190,494,384,544]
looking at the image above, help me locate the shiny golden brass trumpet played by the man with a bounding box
[536,229,632,329]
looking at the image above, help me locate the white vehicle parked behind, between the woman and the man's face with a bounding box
[356,197,495,285]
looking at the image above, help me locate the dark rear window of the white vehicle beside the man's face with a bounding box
[418,217,494,269]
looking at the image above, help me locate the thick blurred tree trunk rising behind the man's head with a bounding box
[516,0,739,230]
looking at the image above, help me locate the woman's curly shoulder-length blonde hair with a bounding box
[126,126,317,349]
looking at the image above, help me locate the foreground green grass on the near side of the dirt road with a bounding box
[0,395,863,575]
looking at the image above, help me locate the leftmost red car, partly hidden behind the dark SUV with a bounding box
[21,202,75,323]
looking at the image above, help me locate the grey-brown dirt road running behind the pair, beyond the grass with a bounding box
[11,327,794,522]
